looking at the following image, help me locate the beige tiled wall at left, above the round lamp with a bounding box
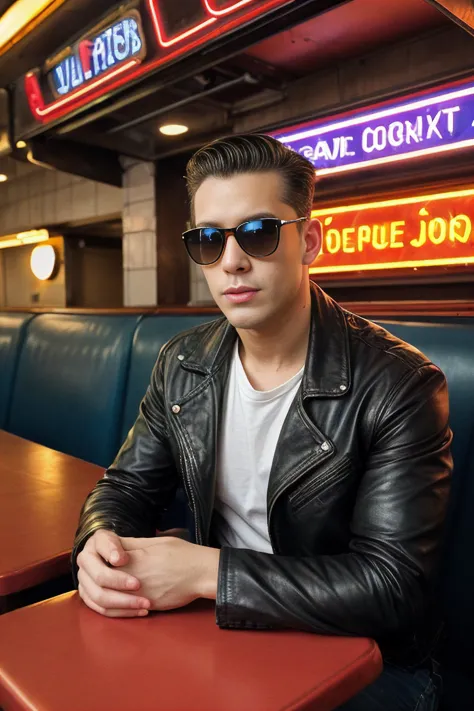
[0,159,122,235]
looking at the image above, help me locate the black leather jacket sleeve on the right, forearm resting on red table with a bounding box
[217,365,452,639]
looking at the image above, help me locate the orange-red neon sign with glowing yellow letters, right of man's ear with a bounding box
[310,189,474,274]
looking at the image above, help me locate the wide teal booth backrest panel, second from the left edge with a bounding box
[8,314,140,466]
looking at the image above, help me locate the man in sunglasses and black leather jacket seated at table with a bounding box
[73,135,451,711]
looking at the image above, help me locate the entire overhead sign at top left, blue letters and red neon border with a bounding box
[24,0,294,123]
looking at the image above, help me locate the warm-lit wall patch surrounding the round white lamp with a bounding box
[2,237,66,308]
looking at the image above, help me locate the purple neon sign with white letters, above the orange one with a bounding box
[273,83,474,176]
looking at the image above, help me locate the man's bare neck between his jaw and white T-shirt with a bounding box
[238,283,311,390]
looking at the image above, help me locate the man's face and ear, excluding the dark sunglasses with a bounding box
[194,172,320,330]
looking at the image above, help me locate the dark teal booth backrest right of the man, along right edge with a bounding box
[381,322,474,711]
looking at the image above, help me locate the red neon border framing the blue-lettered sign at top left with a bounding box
[24,0,294,123]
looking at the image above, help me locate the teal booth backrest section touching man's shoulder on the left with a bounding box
[121,314,216,440]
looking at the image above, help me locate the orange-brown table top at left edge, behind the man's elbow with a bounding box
[0,430,103,596]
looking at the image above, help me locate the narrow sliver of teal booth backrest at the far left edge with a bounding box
[0,313,33,429]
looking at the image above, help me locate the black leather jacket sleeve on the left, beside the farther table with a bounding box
[72,349,178,577]
